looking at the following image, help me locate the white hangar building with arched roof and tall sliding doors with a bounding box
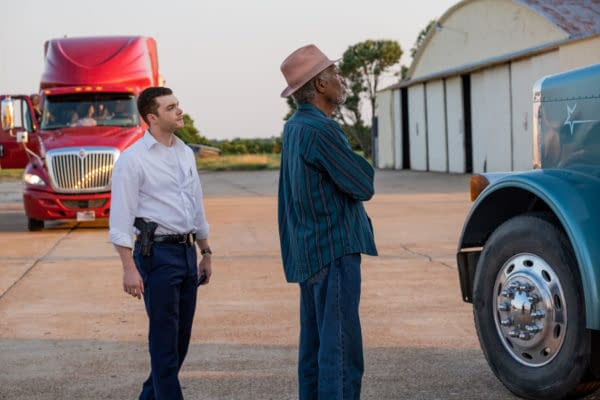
[374,0,600,173]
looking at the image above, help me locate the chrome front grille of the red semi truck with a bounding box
[46,148,118,193]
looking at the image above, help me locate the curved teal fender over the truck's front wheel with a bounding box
[457,169,600,329]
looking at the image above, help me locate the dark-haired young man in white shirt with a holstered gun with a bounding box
[109,87,212,400]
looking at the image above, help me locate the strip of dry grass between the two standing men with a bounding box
[196,154,280,171]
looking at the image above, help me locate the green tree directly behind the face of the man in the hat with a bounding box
[337,40,402,157]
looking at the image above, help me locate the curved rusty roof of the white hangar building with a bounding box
[407,0,600,79]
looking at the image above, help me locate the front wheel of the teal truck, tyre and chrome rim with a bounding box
[473,214,596,399]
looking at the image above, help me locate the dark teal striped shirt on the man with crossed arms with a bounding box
[278,104,377,282]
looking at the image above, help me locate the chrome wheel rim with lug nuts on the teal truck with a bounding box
[493,253,567,367]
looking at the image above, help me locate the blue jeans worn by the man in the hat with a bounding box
[298,254,364,400]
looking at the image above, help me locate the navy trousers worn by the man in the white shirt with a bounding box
[133,243,198,400]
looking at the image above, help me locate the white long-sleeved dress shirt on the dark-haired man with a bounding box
[109,131,209,248]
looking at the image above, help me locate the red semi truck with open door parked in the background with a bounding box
[0,36,162,231]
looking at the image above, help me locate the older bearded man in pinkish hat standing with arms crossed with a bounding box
[278,45,377,400]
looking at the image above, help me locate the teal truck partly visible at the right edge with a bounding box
[457,64,600,400]
